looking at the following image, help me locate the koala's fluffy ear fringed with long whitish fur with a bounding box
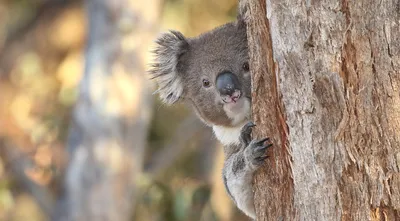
[150,31,189,104]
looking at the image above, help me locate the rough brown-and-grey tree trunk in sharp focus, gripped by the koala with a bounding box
[243,0,400,220]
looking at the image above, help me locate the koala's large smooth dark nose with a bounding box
[216,71,240,96]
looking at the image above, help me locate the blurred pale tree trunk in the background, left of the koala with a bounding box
[53,0,158,221]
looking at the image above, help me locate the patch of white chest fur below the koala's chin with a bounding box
[213,123,245,145]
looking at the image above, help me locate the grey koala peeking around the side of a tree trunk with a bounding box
[149,19,272,219]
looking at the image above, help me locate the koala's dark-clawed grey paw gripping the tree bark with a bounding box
[240,122,272,168]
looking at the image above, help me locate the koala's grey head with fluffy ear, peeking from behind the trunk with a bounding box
[150,21,251,127]
